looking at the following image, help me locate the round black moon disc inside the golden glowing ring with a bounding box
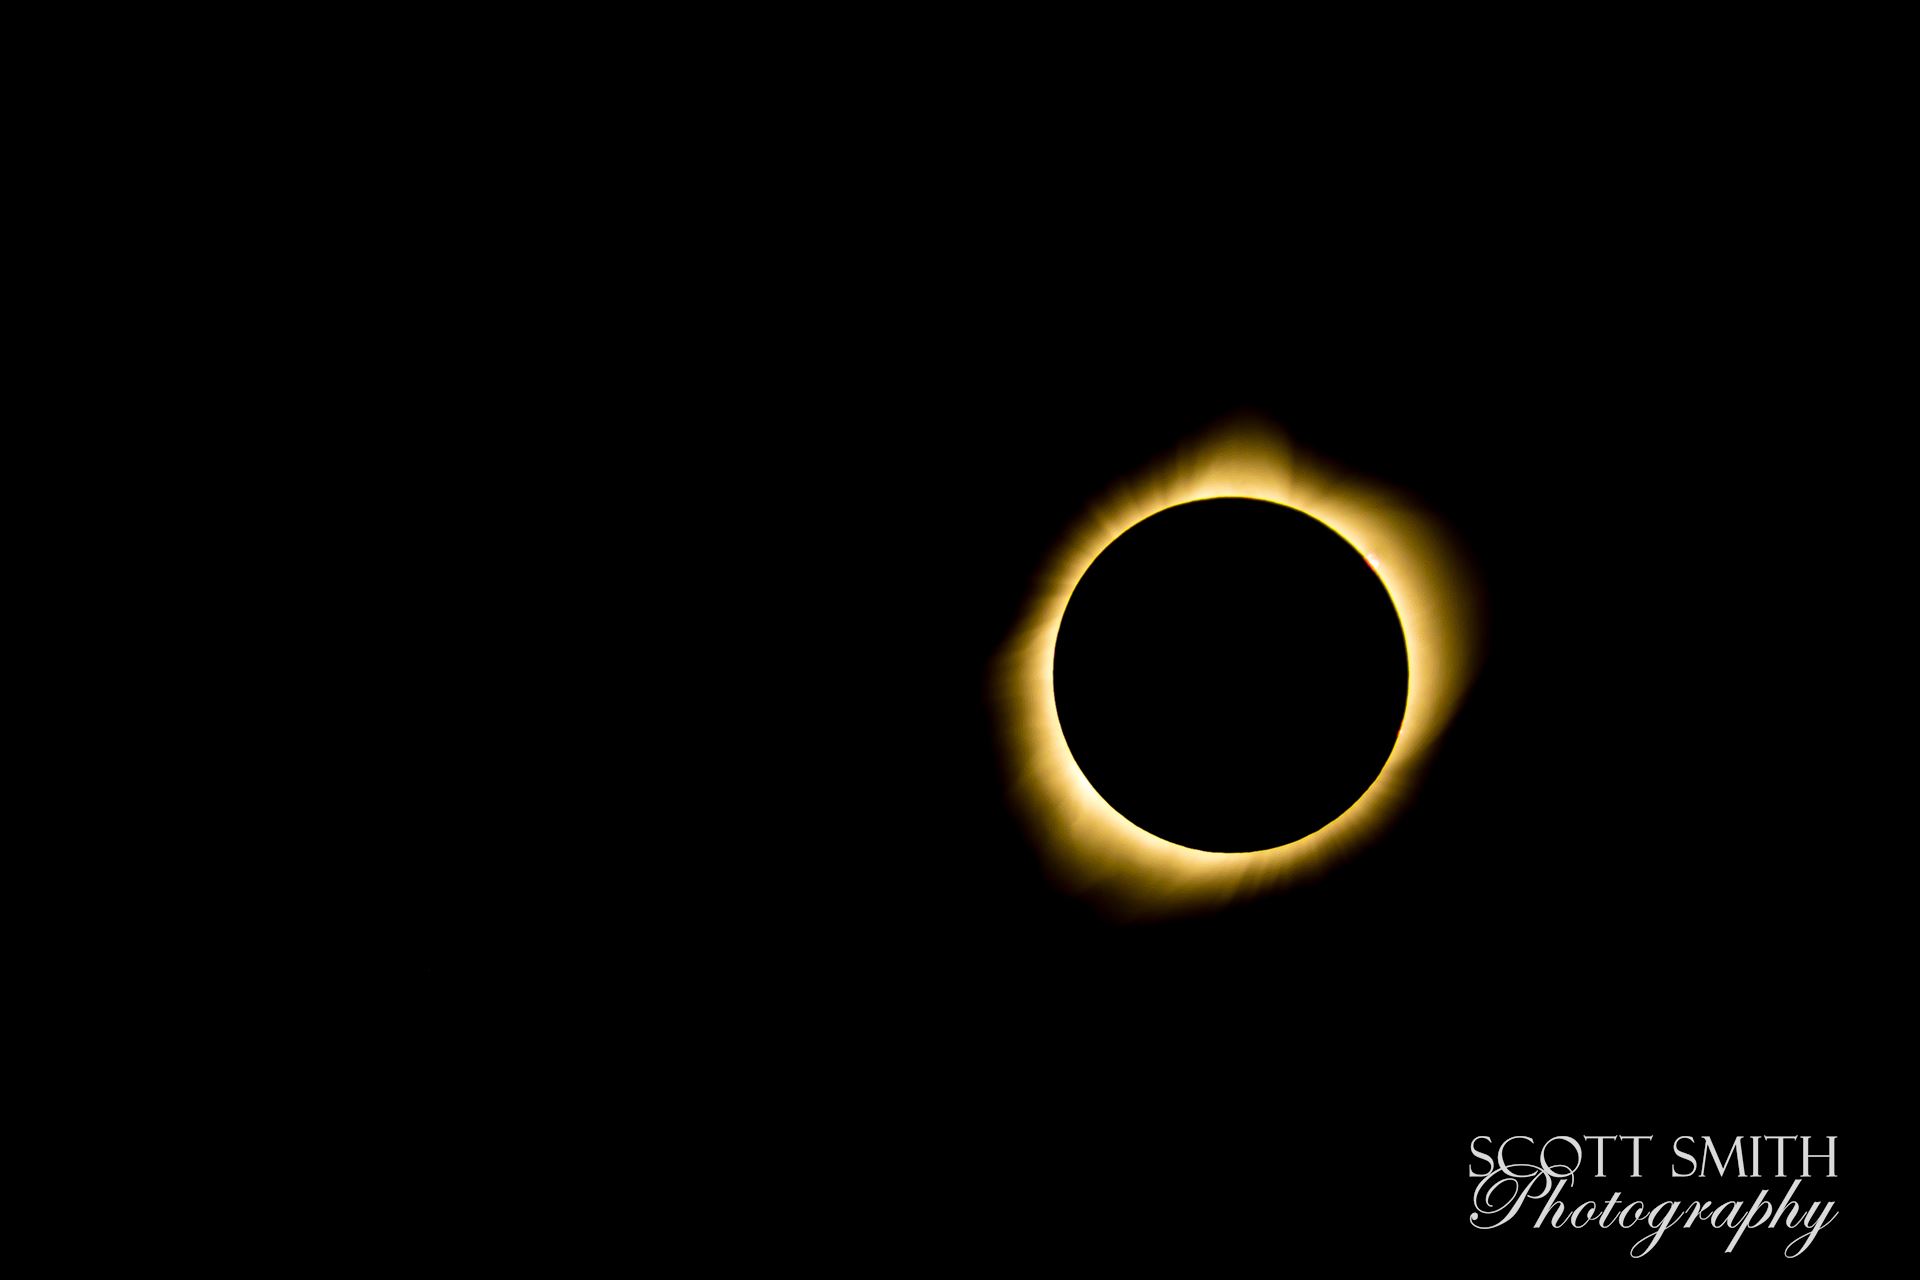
[1052,497,1407,854]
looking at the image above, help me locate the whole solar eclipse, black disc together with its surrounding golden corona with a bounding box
[993,420,1480,919]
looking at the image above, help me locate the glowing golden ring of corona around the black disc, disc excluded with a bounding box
[993,420,1480,919]
